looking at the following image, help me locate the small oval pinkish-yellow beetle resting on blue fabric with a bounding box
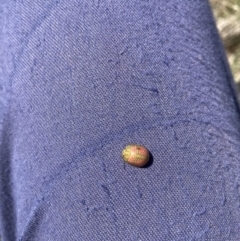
[122,144,150,167]
